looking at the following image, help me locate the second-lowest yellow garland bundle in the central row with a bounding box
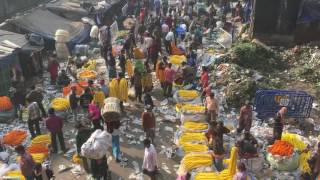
[181,153,213,172]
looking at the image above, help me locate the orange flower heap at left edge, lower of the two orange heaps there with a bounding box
[3,129,27,146]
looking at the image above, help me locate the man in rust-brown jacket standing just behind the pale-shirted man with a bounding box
[141,105,156,144]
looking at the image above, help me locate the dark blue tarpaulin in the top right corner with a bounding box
[297,0,320,23]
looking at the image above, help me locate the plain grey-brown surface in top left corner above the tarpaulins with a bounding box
[0,0,47,22]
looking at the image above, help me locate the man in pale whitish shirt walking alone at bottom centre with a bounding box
[142,139,158,180]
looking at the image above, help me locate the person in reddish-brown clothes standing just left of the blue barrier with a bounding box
[237,101,252,133]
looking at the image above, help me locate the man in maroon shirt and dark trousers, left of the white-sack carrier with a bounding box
[45,108,67,153]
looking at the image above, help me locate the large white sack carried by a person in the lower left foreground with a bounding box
[81,129,112,159]
